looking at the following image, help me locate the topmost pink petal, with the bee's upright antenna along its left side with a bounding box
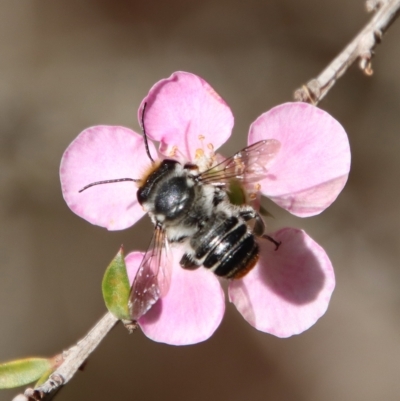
[138,72,233,161]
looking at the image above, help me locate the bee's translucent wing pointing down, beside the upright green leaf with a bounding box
[129,223,171,320]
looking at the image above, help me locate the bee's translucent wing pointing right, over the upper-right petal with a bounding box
[199,139,281,186]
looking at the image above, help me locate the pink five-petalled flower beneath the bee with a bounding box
[60,72,350,345]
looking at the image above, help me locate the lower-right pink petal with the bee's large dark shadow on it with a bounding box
[229,228,335,337]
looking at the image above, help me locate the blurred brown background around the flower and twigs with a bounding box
[0,0,400,401]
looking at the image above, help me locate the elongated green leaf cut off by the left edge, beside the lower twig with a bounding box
[0,358,54,389]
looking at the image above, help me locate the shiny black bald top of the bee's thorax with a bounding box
[154,177,194,219]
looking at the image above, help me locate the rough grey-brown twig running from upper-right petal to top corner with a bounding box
[294,0,400,104]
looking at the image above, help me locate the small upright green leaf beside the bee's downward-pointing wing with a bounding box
[102,247,130,320]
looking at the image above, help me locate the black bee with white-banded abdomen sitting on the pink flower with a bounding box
[80,104,280,321]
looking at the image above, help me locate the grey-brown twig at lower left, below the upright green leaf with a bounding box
[13,312,118,401]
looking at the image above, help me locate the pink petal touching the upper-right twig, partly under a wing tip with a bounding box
[249,103,350,217]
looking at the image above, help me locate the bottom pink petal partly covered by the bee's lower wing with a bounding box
[125,249,225,345]
